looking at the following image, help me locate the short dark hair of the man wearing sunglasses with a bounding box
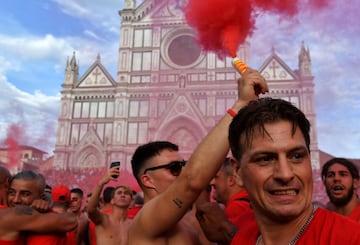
[131,141,179,186]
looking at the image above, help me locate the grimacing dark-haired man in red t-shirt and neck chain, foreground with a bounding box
[229,98,360,245]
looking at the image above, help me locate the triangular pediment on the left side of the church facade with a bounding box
[76,58,116,88]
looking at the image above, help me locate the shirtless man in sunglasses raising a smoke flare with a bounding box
[129,69,268,245]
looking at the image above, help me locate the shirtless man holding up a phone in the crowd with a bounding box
[87,167,132,245]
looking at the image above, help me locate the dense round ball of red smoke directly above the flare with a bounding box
[185,0,255,57]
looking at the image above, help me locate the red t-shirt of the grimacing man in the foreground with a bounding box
[231,208,360,245]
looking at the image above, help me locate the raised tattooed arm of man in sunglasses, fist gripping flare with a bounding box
[134,69,268,238]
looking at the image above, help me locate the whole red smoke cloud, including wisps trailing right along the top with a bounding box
[185,0,327,57]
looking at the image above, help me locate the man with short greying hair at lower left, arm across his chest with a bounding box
[0,168,77,244]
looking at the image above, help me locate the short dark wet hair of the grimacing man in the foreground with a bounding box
[228,98,310,160]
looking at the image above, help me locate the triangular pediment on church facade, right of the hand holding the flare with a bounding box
[259,52,297,81]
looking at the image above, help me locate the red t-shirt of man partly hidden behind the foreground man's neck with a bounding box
[224,190,251,224]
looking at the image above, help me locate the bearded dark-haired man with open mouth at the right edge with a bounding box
[321,158,360,222]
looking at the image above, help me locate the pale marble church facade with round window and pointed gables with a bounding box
[54,0,320,172]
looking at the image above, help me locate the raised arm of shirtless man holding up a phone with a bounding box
[87,167,119,225]
